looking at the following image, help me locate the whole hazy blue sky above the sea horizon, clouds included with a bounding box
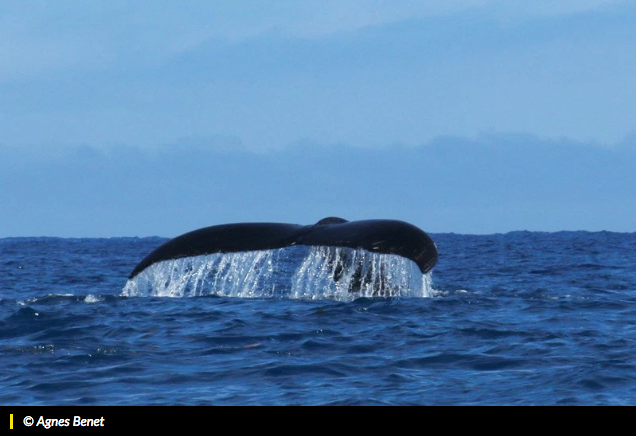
[0,0,636,237]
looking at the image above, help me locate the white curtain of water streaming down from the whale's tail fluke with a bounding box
[122,246,433,301]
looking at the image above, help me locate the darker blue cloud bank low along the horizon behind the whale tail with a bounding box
[0,135,636,237]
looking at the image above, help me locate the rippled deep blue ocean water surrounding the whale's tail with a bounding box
[0,232,636,405]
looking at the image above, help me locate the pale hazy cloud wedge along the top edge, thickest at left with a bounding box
[0,0,626,81]
